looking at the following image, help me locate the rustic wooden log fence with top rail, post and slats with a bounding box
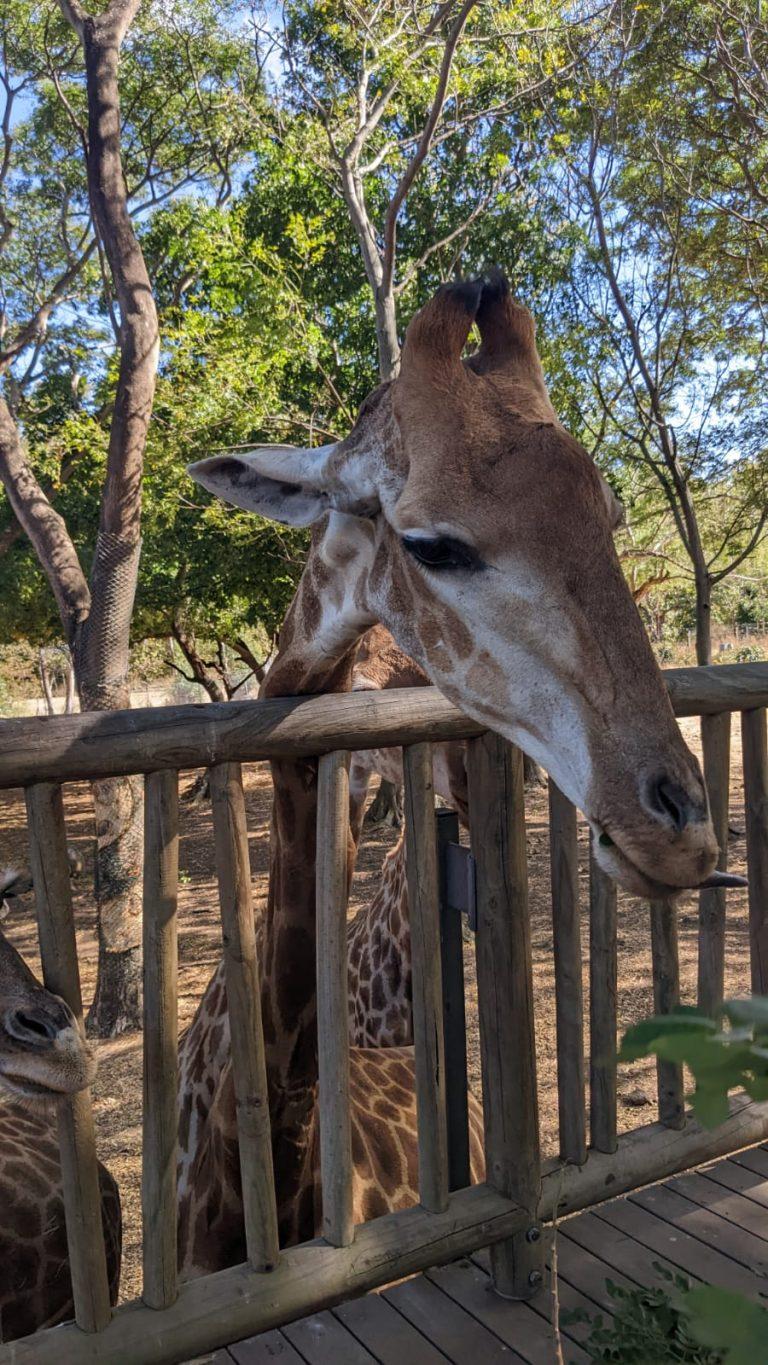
[0,665,768,1365]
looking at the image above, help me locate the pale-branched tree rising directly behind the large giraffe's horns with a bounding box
[262,0,570,379]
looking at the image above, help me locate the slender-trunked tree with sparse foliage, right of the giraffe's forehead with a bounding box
[529,4,768,663]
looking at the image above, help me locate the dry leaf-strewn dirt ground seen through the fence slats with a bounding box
[0,721,749,1299]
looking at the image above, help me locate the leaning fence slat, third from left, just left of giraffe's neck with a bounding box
[210,763,278,1269]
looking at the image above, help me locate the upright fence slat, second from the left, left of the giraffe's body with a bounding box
[142,771,179,1308]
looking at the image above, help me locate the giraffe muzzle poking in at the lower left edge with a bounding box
[0,884,95,1103]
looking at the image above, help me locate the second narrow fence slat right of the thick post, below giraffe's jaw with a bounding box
[589,835,618,1152]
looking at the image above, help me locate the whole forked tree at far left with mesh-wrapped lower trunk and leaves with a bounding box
[0,0,266,1033]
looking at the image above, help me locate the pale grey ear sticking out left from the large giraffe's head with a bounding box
[187,444,378,526]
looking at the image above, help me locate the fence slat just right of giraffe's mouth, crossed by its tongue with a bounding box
[698,711,731,1014]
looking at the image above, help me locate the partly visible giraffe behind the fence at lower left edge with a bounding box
[0,883,121,1342]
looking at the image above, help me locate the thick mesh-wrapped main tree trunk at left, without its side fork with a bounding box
[67,0,160,1037]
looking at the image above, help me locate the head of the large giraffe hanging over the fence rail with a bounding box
[191,277,718,895]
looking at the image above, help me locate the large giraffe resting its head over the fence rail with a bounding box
[181,277,718,1268]
